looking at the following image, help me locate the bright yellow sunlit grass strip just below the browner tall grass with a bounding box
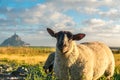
[0,54,47,65]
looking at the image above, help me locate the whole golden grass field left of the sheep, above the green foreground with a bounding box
[0,47,55,65]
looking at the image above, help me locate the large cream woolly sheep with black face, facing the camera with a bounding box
[47,28,115,80]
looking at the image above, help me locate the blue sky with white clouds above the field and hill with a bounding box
[0,0,120,47]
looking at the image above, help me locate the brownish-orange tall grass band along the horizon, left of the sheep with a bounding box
[0,47,55,55]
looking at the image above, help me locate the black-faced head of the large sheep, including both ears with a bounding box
[47,28,85,54]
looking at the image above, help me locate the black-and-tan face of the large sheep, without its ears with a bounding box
[56,31,73,53]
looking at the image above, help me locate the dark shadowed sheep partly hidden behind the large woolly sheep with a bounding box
[43,52,55,73]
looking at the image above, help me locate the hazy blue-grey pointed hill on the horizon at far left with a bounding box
[0,33,30,46]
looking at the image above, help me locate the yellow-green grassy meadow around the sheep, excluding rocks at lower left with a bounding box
[0,47,120,80]
